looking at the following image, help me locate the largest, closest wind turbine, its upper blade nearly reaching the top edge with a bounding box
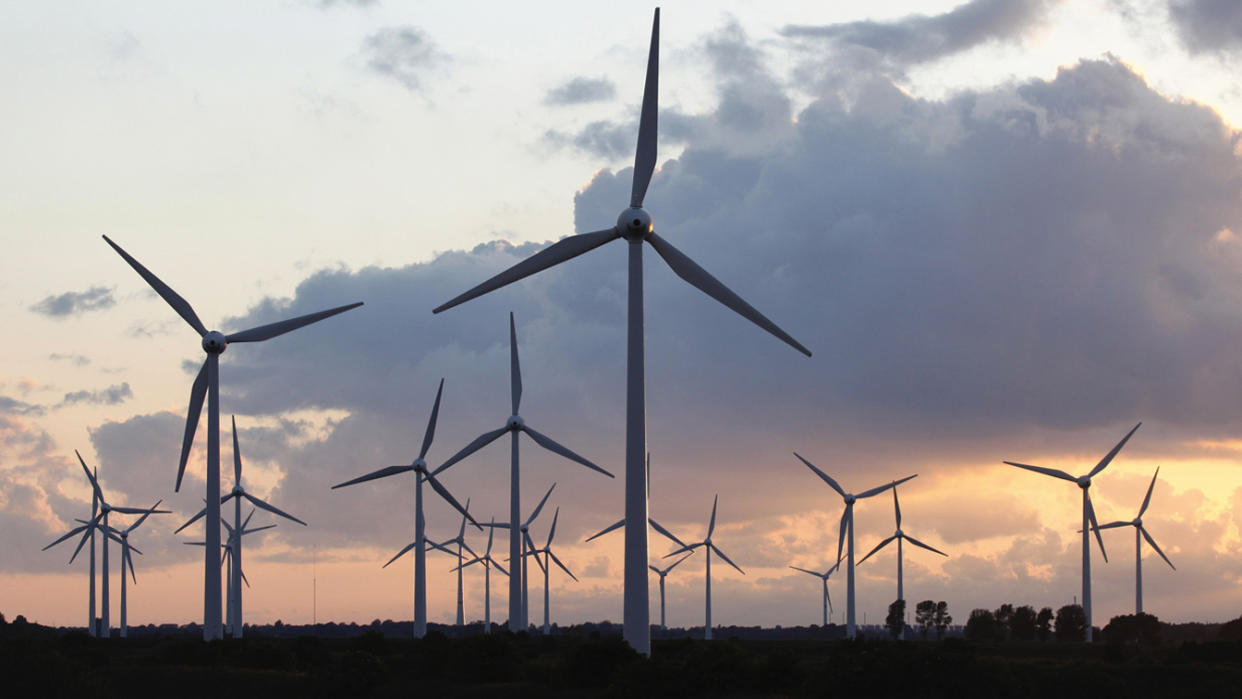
[433,7,811,656]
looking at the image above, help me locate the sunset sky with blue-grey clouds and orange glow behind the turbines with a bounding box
[0,0,1242,626]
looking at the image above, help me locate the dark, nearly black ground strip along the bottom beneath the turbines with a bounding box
[0,625,1242,699]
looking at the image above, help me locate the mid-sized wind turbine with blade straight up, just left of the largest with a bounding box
[432,312,612,631]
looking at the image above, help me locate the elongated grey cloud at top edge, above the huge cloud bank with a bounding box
[781,0,1058,66]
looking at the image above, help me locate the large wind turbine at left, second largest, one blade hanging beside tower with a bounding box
[103,236,363,641]
